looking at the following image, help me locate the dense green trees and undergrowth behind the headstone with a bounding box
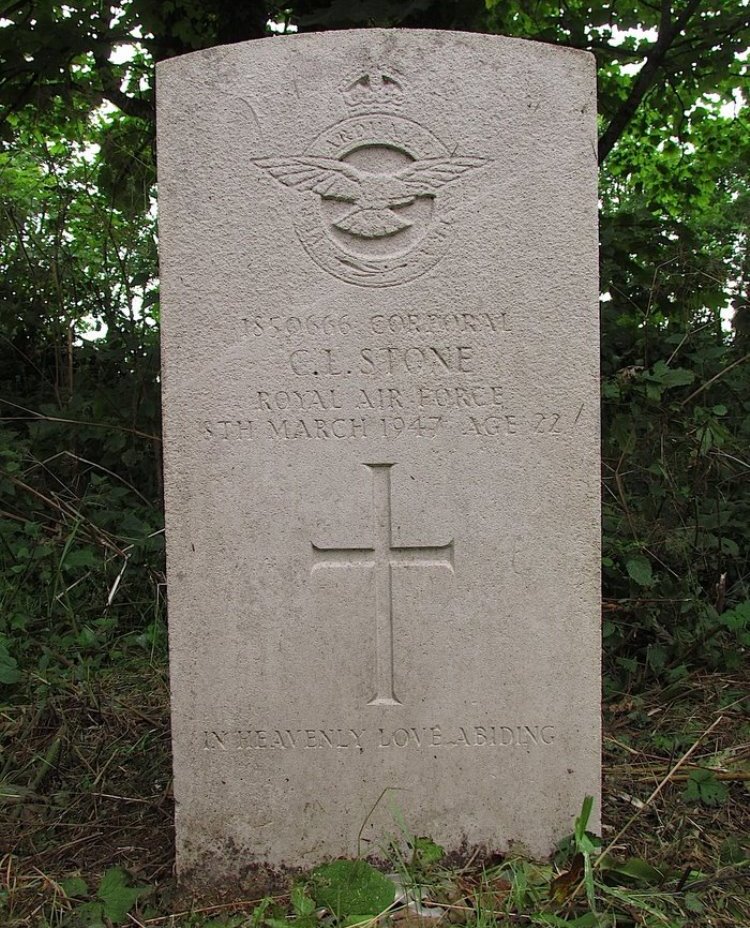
[0,0,750,686]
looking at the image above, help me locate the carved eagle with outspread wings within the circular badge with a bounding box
[254,155,486,239]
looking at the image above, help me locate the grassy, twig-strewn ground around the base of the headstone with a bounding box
[0,667,750,928]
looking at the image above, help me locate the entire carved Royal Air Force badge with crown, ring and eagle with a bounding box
[251,83,492,287]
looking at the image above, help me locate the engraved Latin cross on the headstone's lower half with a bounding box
[312,464,453,706]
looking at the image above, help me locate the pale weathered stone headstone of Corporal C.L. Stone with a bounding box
[159,30,600,879]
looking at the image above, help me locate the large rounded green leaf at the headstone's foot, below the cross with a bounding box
[309,860,396,920]
